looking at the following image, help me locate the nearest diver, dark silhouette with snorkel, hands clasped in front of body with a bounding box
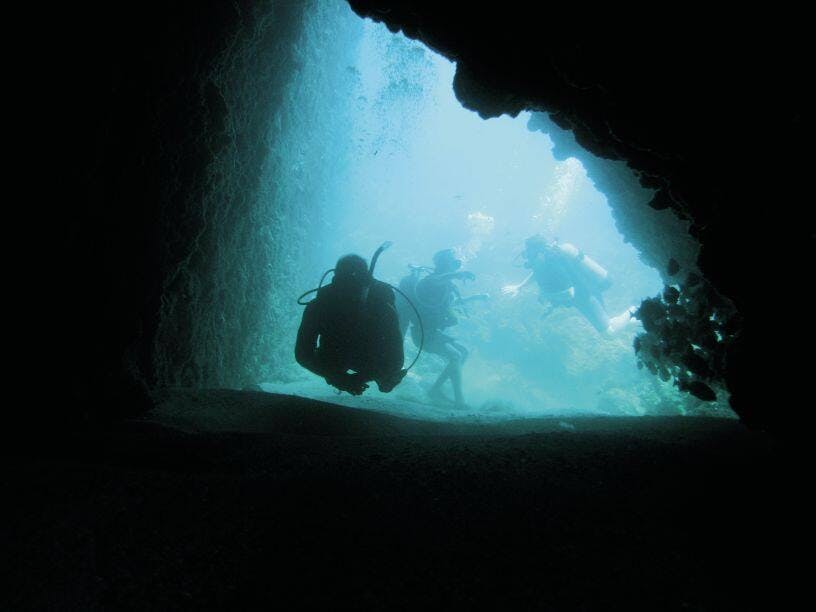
[295,251,407,395]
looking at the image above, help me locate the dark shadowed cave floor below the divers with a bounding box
[7,391,792,610]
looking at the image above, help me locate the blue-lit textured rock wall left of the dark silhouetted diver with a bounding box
[154,2,362,388]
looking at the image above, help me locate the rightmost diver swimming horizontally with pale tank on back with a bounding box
[502,234,637,334]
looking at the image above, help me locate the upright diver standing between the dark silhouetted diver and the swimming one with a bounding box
[399,249,487,408]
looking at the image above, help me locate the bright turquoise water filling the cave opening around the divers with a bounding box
[263,7,724,419]
